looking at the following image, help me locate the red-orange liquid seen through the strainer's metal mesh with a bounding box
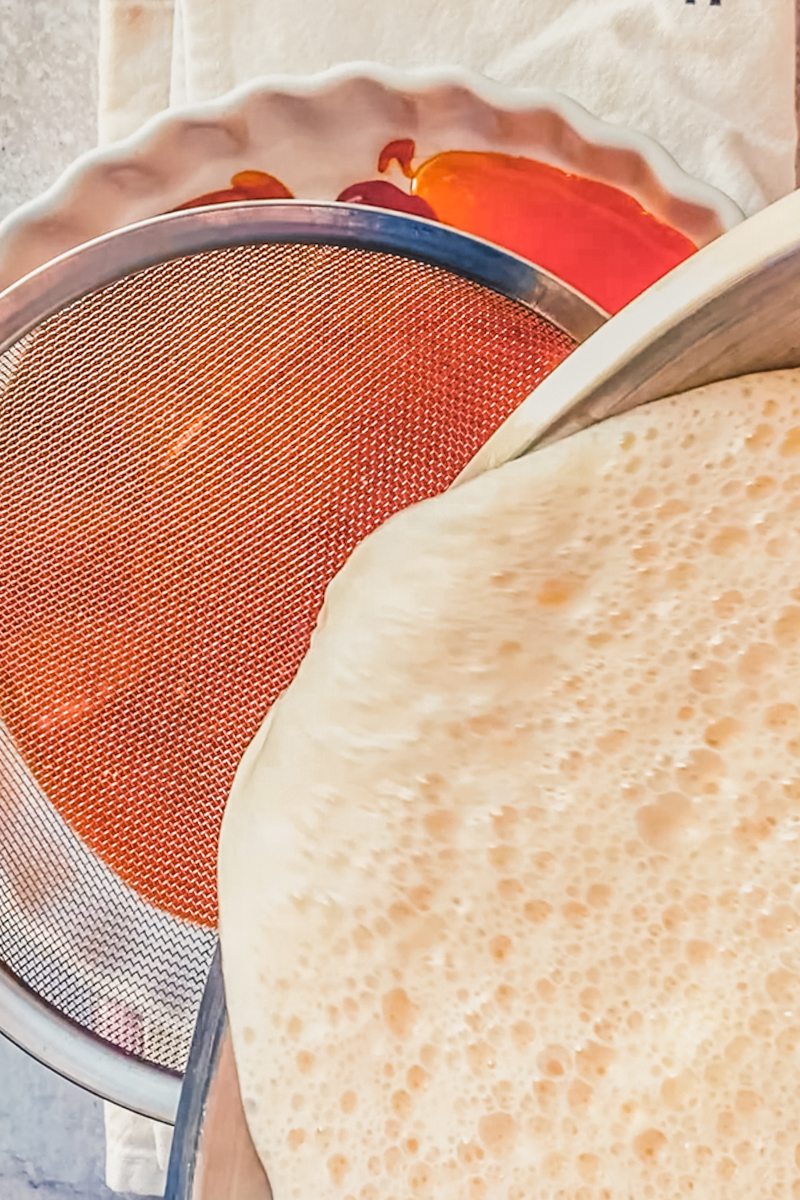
[0,238,573,925]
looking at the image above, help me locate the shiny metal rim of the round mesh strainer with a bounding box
[0,200,607,1123]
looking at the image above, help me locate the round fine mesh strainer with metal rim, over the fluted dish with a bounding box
[0,203,603,1121]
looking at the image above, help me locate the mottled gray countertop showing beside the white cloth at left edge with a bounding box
[0,14,155,1200]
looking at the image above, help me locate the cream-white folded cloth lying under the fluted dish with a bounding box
[100,0,796,1194]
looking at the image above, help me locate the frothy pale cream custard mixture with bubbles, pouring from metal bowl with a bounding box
[221,372,800,1200]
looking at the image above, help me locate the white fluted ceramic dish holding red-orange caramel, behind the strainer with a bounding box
[0,64,741,308]
